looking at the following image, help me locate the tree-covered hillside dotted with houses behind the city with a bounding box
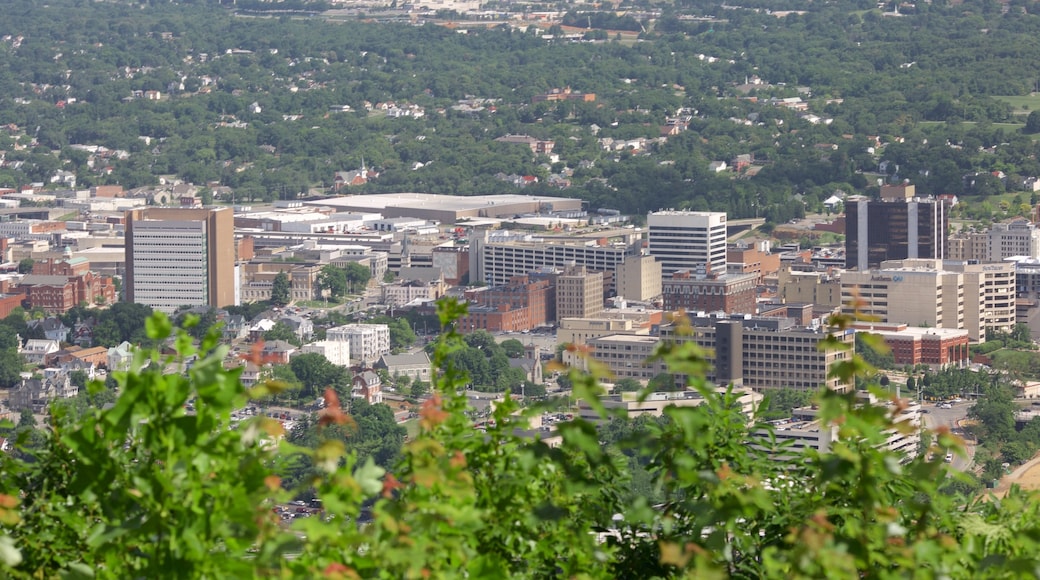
[0,0,1040,221]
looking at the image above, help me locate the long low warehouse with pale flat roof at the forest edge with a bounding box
[305,193,581,223]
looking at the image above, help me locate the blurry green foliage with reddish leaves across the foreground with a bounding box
[0,302,1040,578]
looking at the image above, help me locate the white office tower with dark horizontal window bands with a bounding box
[647,210,726,278]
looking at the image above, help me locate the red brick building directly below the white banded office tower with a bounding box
[660,270,758,314]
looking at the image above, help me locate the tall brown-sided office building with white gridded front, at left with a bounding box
[125,208,235,313]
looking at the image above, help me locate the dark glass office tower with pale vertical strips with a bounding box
[846,185,950,270]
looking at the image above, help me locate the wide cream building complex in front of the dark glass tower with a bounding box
[841,259,1015,342]
